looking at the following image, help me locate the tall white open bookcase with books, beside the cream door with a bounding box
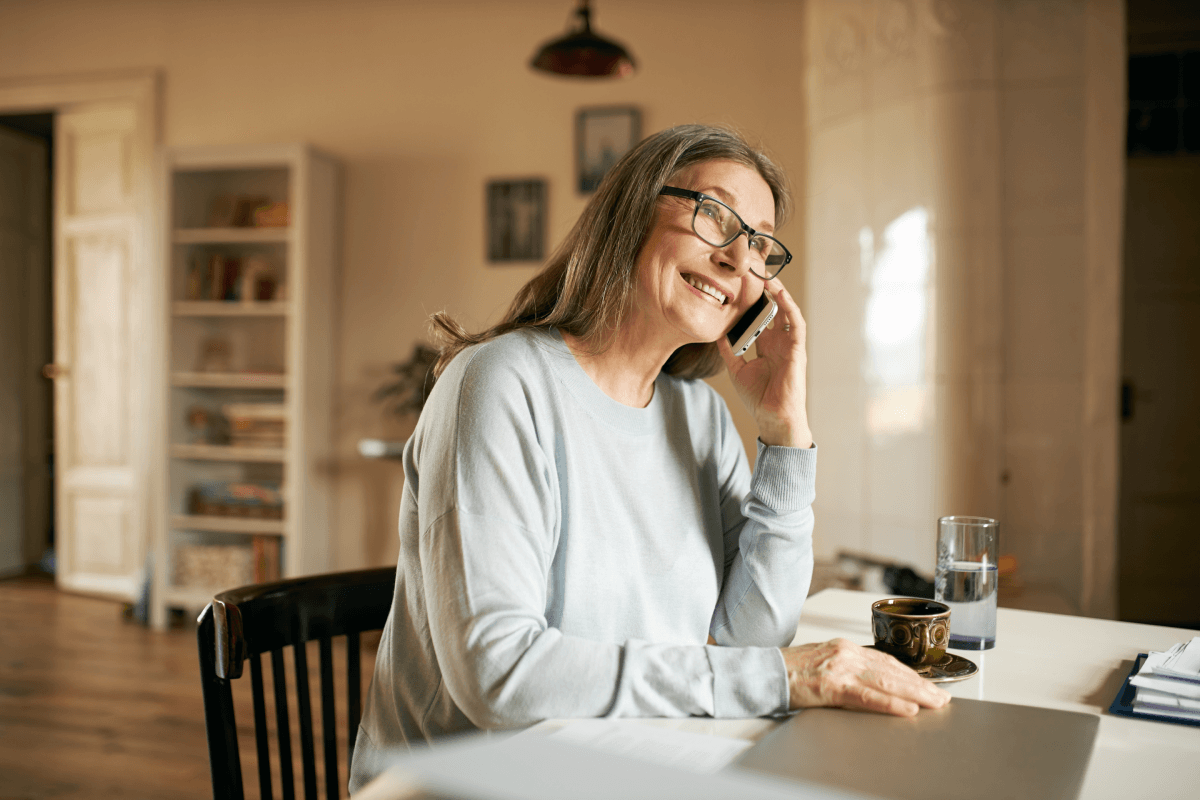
[151,145,338,627]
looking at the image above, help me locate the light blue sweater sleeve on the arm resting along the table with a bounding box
[419,347,787,728]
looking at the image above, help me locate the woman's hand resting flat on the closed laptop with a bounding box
[782,639,950,717]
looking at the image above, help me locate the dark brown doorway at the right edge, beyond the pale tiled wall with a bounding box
[1118,0,1200,628]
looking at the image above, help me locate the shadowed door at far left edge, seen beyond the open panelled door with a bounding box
[0,123,49,577]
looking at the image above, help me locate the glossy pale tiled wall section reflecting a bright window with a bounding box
[806,0,1124,615]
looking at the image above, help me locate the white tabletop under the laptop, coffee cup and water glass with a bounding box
[356,589,1200,800]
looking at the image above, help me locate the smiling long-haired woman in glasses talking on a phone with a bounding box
[352,125,949,788]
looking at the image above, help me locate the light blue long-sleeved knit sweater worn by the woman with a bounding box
[350,330,816,790]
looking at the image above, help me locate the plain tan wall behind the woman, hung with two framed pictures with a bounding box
[0,0,805,567]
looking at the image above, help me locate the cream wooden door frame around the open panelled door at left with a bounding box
[0,68,167,597]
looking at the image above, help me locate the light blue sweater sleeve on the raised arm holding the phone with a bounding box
[710,400,817,648]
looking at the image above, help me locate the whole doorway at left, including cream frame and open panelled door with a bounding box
[0,70,166,600]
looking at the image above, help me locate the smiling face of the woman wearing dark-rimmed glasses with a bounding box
[632,161,775,349]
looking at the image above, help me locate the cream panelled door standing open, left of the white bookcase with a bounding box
[54,103,154,599]
